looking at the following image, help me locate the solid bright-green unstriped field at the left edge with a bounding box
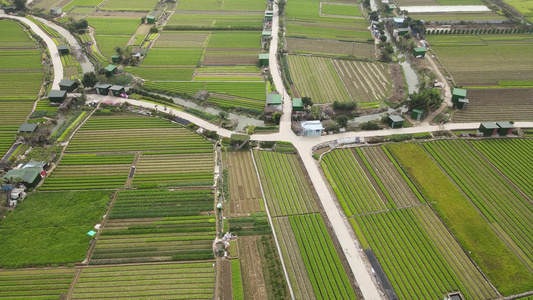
[0,191,111,268]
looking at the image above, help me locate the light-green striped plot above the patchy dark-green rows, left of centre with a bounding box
[133,150,214,187]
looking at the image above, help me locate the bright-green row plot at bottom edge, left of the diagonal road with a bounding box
[289,214,356,299]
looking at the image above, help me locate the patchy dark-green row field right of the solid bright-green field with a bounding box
[90,189,216,264]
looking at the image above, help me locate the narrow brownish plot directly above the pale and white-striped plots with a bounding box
[287,37,376,59]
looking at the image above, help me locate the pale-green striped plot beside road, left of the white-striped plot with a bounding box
[288,55,353,103]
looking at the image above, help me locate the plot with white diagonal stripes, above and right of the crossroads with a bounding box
[332,60,392,102]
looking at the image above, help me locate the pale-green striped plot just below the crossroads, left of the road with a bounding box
[254,151,318,216]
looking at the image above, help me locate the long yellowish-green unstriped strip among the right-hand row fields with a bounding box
[387,143,533,295]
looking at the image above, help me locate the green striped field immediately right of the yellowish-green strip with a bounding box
[423,140,533,265]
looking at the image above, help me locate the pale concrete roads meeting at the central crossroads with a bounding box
[9,9,533,300]
